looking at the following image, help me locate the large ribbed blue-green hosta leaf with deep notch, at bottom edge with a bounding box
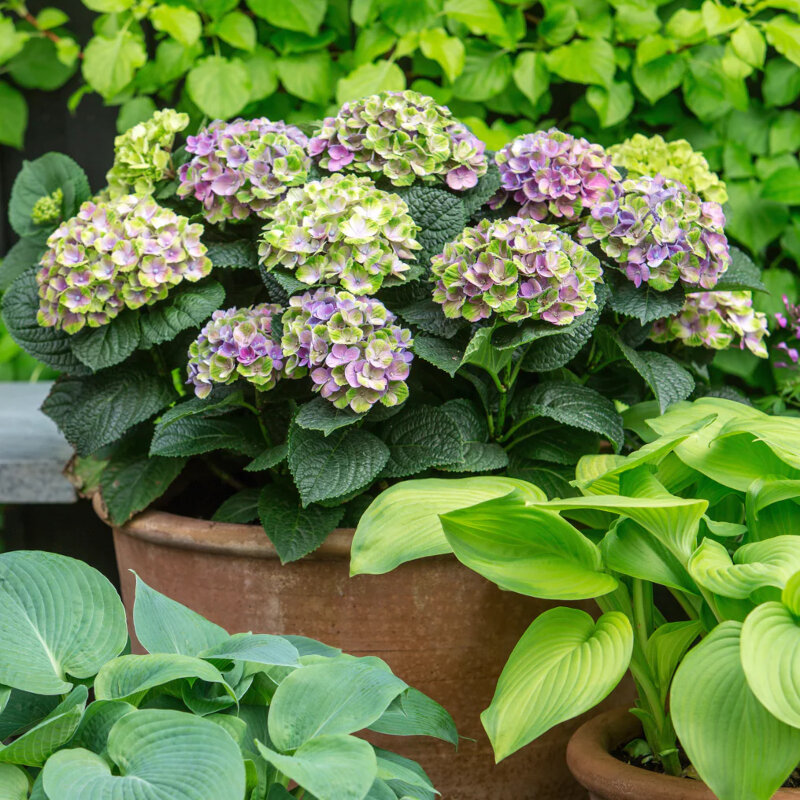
[44,709,245,800]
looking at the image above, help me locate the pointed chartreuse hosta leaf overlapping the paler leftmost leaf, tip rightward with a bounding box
[441,491,617,600]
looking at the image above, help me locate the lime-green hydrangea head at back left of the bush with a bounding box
[106,108,189,197]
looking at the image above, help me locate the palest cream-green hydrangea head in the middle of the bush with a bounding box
[259,175,420,294]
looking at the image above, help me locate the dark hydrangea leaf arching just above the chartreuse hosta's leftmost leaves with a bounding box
[513,381,624,452]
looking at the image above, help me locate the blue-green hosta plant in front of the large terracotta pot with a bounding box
[0,551,457,800]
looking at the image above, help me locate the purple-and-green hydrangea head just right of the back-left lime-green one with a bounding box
[178,117,311,223]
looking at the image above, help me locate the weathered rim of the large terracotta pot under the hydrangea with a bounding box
[92,492,355,560]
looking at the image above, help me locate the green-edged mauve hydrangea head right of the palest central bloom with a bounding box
[431,217,603,325]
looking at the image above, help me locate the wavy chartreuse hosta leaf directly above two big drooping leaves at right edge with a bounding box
[689,536,800,600]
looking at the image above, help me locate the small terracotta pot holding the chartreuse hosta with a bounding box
[567,708,800,800]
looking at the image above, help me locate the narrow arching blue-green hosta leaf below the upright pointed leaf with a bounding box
[94,653,236,705]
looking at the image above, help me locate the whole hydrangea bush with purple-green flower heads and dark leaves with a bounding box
[0,98,766,561]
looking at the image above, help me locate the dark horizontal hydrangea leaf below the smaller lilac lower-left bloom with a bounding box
[150,413,264,458]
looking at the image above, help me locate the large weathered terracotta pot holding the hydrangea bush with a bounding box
[96,501,629,800]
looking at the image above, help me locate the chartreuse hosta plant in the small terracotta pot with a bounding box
[352,398,800,800]
